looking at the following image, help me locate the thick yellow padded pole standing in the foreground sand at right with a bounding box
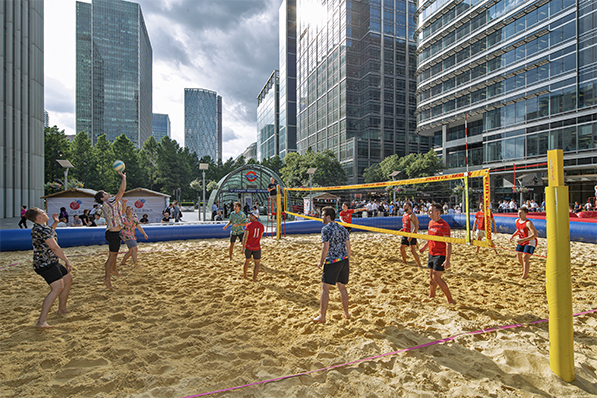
[545,149,574,383]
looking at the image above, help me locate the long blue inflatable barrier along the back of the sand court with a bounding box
[0,214,597,252]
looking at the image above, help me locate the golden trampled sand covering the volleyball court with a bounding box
[0,232,597,397]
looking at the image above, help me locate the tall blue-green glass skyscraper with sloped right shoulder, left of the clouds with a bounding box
[76,0,153,147]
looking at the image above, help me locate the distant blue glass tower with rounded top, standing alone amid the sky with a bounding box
[184,88,222,160]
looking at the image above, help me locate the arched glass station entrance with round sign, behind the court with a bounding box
[208,164,285,215]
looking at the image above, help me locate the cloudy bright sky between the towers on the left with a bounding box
[44,0,282,160]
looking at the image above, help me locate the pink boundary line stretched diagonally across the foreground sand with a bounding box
[181,309,597,398]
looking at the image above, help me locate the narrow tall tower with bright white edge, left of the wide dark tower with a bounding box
[278,0,296,160]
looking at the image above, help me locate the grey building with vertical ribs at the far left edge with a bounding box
[0,0,44,218]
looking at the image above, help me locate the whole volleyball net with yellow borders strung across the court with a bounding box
[283,169,492,247]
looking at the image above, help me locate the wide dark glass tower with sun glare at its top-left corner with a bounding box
[297,0,430,183]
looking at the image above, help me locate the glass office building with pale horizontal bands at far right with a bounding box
[417,0,597,201]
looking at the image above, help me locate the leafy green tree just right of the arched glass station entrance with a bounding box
[280,150,348,187]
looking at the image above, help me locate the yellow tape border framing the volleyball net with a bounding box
[284,169,493,247]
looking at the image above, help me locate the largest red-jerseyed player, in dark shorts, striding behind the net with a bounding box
[420,203,456,304]
